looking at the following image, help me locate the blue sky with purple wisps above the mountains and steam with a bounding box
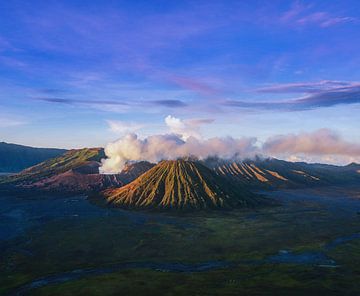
[0,0,360,160]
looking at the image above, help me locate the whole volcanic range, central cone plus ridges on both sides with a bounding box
[0,144,360,209]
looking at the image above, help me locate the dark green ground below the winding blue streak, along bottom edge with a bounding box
[29,266,359,296]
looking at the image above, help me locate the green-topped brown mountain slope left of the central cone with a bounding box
[0,148,153,193]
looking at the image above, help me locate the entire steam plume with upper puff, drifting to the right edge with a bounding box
[100,116,360,173]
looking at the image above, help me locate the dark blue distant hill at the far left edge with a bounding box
[0,142,66,172]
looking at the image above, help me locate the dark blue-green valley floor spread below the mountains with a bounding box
[0,187,360,295]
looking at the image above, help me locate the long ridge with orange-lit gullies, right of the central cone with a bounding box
[205,159,360,188]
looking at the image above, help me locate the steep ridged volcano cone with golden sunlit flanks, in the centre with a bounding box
[102,160,266,209]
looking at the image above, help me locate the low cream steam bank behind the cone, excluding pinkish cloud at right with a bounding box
[100,134,257,173]
